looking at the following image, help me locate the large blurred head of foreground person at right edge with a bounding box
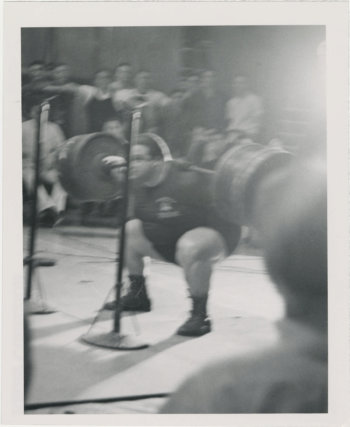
[256,157,327,329]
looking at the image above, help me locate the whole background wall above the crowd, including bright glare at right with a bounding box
[22,26,325,142]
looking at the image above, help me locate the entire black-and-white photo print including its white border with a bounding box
[3,2,349,426]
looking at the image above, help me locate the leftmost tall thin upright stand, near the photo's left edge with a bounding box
[23,98,55,314]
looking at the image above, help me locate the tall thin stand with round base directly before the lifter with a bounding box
[81,108,148,350]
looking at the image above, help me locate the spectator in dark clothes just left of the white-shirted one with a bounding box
[188,70,226,132]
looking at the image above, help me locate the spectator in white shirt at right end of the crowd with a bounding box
[226,76,263,142]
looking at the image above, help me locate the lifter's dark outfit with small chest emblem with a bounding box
[134,165,240,262]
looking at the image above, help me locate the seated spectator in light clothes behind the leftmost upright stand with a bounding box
[22,96,67,226]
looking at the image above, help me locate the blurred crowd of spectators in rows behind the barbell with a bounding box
[22,61,262,151]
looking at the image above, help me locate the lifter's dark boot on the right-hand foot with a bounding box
[177,295,211,337]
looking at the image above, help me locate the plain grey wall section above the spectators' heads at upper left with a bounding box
[22,27,182,90]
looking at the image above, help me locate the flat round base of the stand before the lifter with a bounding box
[81,331,149,350]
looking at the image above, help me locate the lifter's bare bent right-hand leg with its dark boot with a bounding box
[176,227,227,336]
